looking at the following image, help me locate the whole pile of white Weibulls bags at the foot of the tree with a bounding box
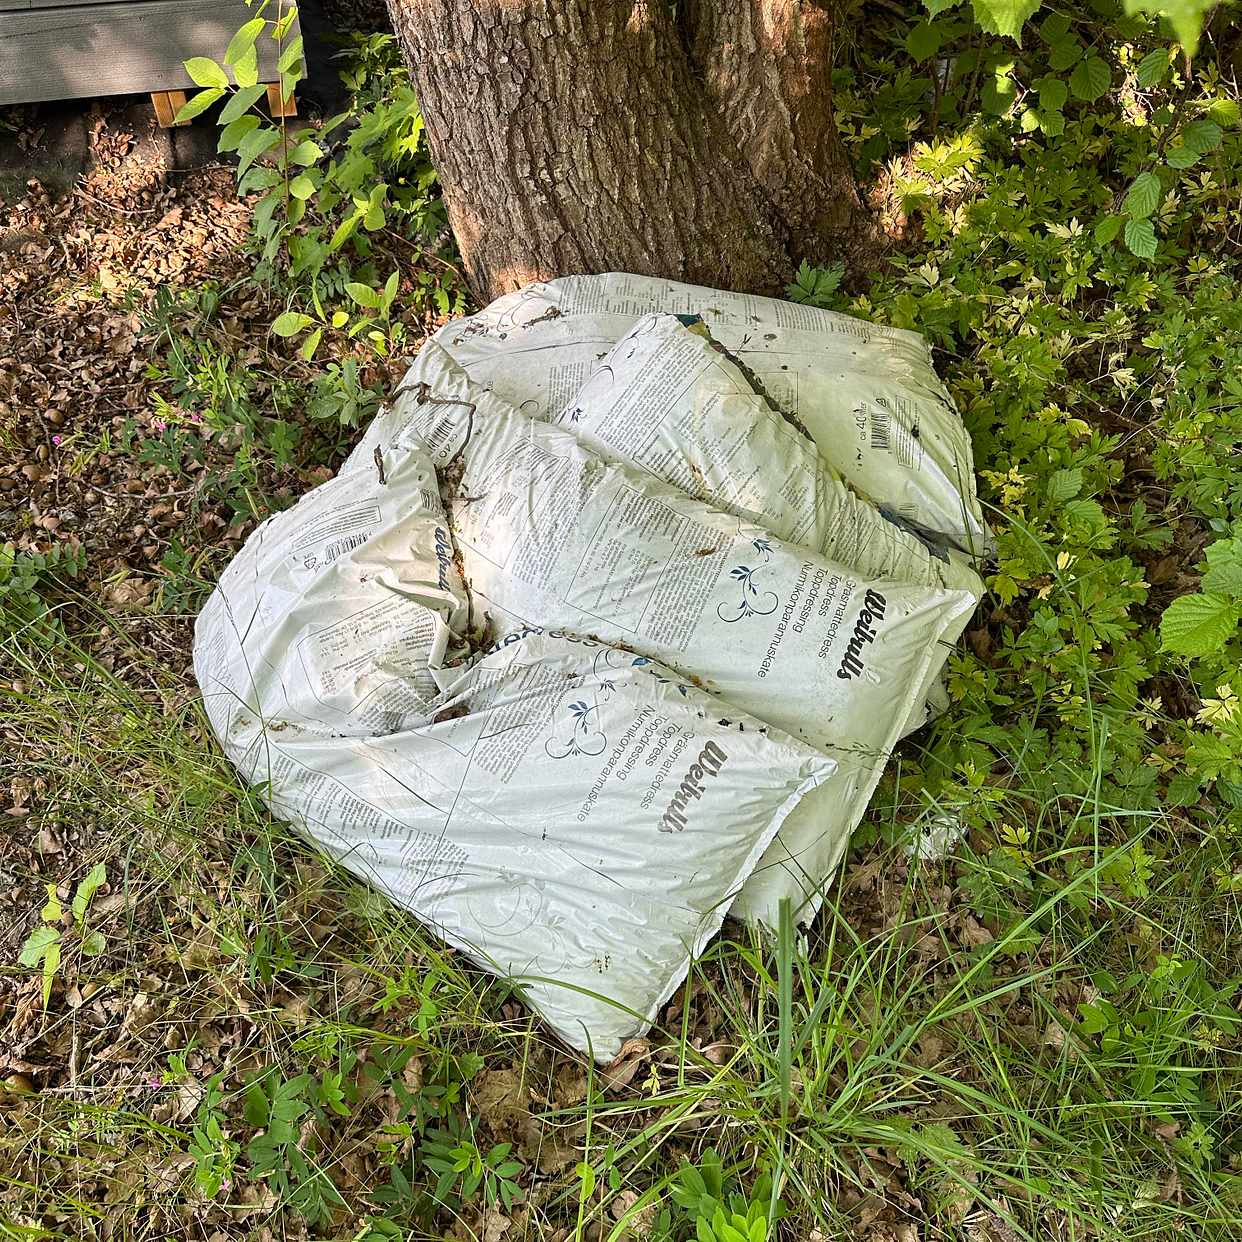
[194,273,990,1061]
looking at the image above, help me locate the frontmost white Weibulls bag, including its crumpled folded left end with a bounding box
[195,437,833,1061]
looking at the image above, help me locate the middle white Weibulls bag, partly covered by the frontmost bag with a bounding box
[367,343,975,924]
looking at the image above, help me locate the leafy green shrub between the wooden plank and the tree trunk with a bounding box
[179,8,465,360]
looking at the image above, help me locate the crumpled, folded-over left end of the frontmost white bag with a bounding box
[195,451,467,748]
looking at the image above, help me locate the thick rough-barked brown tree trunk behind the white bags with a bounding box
[389,0,859,301]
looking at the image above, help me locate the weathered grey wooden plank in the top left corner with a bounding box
[0,0,297,106]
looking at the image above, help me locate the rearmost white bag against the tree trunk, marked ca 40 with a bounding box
[433,279,991,555]
